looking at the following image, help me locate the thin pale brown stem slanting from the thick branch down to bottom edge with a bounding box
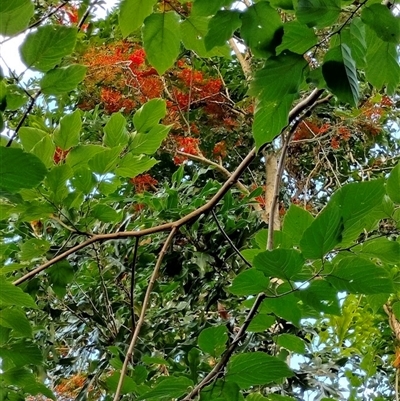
[113,226,177,401]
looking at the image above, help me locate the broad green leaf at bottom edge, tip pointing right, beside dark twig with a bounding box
[226,352,293,389]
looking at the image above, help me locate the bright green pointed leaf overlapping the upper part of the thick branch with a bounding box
[253,95,297,149]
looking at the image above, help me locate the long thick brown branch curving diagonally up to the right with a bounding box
[14,90,323,285]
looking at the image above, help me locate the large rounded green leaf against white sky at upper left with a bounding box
[20,25,77,72]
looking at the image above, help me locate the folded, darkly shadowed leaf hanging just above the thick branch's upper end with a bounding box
[322,44,359,106]
